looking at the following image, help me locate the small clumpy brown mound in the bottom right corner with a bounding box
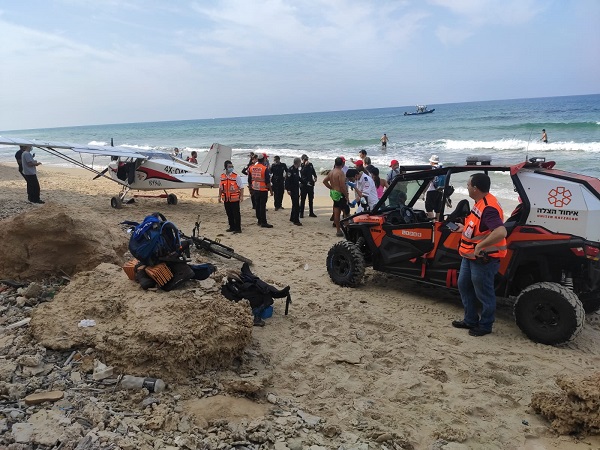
[531,372,600,434]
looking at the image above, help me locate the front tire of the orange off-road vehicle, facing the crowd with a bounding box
[327,241,365,287]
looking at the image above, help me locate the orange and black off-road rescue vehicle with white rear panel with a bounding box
[327,157,600,344]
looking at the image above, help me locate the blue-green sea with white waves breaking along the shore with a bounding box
[0,94,600,203]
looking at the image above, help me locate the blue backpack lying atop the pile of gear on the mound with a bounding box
[124,213,181,266]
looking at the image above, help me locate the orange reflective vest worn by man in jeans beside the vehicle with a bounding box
[458,193,506,259]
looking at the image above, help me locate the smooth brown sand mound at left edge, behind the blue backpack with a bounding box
[0,203,127,280]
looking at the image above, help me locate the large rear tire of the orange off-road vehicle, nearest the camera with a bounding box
[513,282,585,345]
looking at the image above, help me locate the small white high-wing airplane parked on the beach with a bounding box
[0,136,231,209]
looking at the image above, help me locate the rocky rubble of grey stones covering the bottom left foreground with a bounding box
[0,280,412,450]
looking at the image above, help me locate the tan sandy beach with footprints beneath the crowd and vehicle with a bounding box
[0,164,600,450]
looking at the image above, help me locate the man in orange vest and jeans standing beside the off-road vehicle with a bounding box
[452,173,506,336]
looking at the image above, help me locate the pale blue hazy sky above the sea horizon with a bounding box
[0,0,600,130]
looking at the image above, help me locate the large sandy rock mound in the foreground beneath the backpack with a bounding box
[30,264,252,381]
